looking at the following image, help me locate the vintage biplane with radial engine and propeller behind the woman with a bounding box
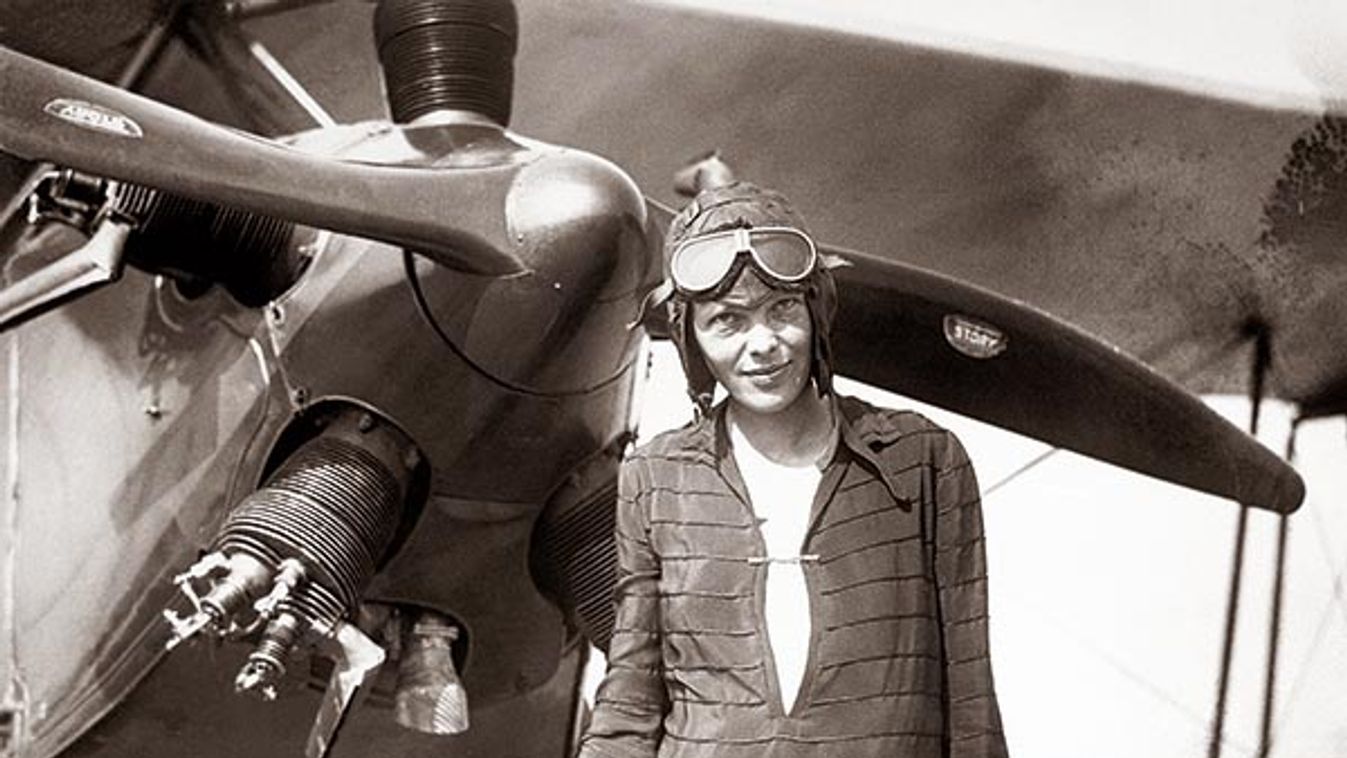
[0,0,1347,758]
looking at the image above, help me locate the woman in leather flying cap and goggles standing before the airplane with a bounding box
[581,183,1006,758]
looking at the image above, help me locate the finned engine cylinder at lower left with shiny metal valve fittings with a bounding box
[166,404,428,699]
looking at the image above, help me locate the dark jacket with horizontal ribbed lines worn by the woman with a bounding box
[581,397,1006,758]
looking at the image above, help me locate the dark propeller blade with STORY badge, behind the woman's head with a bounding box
[827,250,1305,513]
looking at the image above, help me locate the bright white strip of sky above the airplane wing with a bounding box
[663,0,1347,105]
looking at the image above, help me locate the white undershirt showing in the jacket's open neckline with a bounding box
[729,423,823,714]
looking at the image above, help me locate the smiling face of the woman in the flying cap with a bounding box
[692,267,814,413]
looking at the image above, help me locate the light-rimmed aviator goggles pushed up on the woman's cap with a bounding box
[669,226,819,296]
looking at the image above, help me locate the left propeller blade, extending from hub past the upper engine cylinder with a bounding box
[0,47,527,276]
